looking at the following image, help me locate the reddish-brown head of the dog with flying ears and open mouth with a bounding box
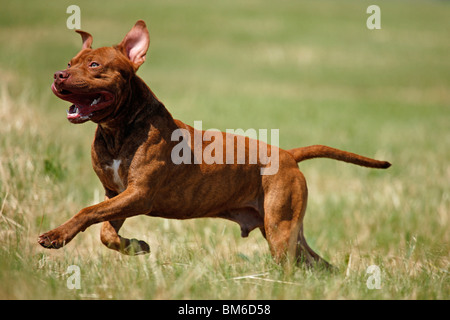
[52,20,150,123]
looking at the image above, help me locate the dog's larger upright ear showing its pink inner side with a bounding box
[117,20,150,70]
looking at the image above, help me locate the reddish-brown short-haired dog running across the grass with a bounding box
[39,21,390,264]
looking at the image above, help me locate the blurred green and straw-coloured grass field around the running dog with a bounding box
[0,0,450,299]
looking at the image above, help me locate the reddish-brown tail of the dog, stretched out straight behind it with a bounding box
[287,145,391,169]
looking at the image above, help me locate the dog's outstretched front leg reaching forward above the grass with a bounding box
[38,186,151,249]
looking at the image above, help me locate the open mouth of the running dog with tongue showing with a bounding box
[52,83,114,123]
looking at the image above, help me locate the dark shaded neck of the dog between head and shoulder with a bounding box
[97,75,174,154]
